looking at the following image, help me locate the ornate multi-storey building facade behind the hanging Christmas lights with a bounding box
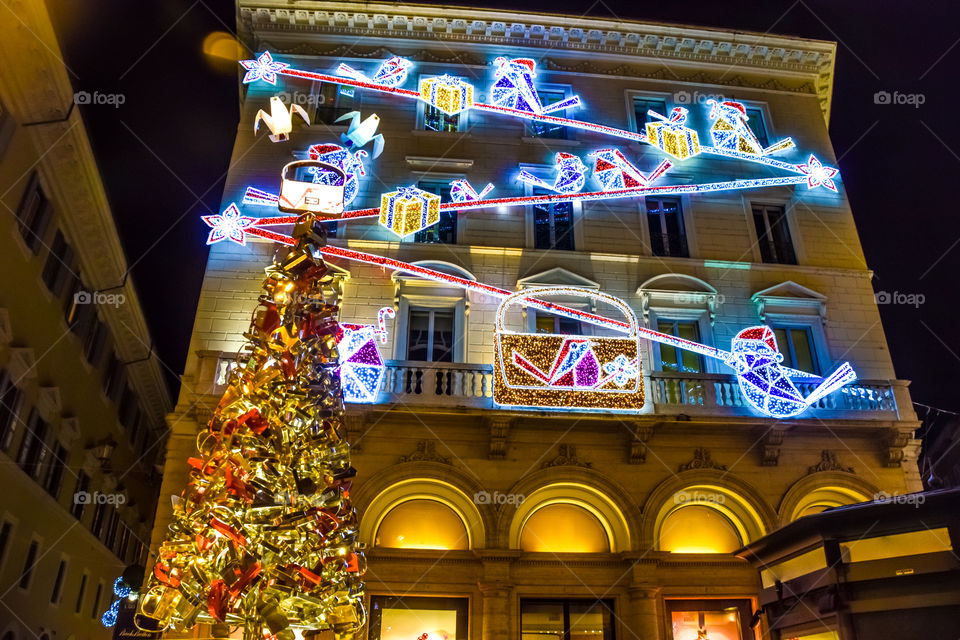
[152,5,920,640]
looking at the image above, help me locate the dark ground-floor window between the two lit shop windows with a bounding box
[520,599,614,640]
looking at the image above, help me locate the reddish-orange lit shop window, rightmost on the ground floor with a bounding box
[665,600,754,640]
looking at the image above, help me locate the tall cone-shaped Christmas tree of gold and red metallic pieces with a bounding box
[139,216,365,640]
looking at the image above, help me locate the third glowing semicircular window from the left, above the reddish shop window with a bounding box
[660,505,743,553]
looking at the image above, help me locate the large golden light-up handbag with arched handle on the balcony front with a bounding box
[493,287,644,411]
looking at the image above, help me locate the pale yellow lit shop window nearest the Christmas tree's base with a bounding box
[370,596,470,640]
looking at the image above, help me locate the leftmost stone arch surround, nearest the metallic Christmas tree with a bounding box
[352,461,495,549]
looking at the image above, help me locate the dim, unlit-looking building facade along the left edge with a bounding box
[0,2,171,640]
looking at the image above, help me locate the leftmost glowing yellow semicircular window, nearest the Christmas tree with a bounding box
[376,500,470,552]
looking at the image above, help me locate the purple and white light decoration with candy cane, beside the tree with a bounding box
[337,307,396,402]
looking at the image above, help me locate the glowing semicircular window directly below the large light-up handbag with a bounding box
[520,503,610,553]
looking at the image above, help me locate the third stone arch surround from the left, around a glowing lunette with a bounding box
[641,469,778,549]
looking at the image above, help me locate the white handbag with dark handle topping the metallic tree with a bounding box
[277,160,347,219]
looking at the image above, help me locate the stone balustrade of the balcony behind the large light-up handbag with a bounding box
[201,352,906,420]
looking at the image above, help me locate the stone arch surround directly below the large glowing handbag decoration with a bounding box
[497,466,639,553]
